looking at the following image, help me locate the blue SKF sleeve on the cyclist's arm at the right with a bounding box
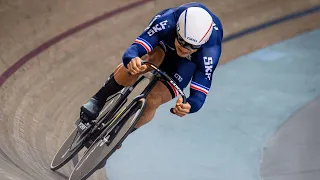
[187,45,221,113]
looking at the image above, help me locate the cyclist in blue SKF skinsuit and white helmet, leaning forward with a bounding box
[81,2,223,138]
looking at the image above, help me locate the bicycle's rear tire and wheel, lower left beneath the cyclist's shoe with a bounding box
[50,93,122,171]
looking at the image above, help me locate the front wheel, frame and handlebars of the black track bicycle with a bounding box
[69,61,186,180]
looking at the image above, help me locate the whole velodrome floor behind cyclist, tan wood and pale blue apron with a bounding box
[0,0,320,180]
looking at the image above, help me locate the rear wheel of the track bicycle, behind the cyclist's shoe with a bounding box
[50,93,122,170]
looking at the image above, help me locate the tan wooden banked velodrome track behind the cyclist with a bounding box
[0,0,320,180]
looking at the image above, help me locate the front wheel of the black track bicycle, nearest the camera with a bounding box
[69,98,146,180]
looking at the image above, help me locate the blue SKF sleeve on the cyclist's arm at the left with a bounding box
[122,17,170,67]
